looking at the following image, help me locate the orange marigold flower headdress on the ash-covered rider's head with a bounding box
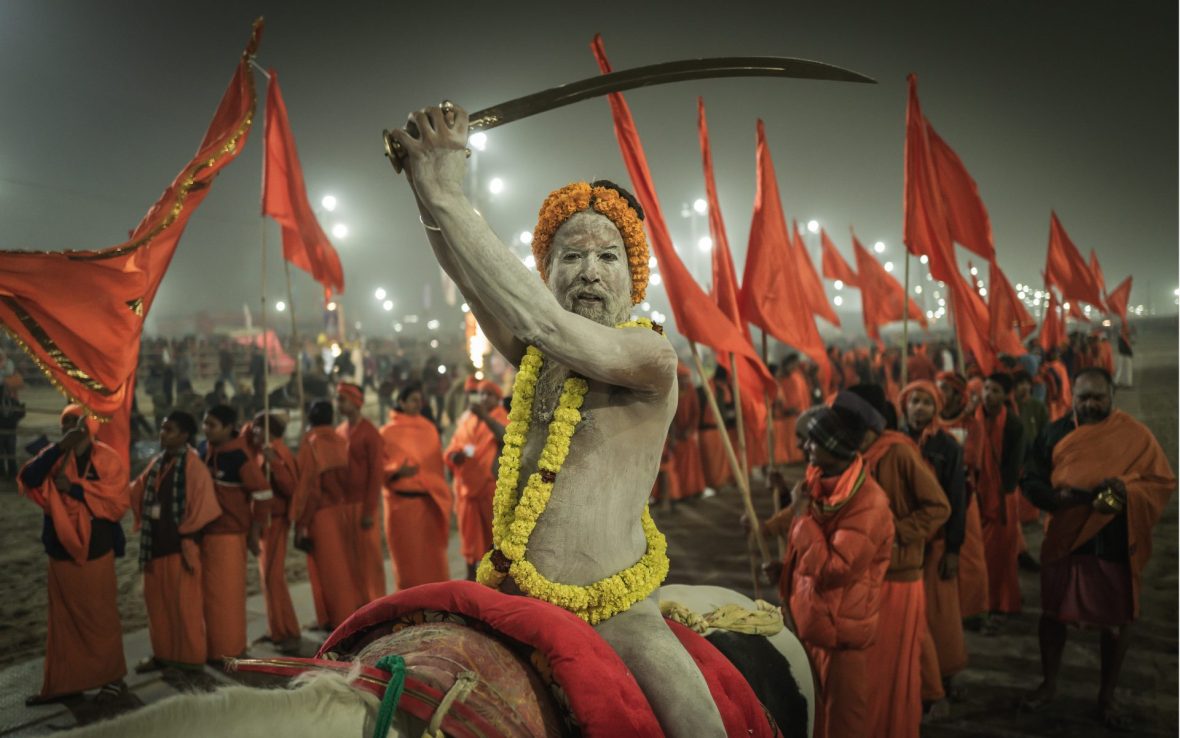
[532,179,651,305]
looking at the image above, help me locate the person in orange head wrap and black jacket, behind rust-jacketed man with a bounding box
[900,379,966,716]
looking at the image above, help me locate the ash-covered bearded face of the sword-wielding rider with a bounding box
[549,211,631,326]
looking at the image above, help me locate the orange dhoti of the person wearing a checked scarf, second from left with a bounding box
[144,550,208,667]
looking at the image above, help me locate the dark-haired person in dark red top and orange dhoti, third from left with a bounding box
[198,405,274,662]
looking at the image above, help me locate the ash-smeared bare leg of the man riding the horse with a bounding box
[597,597,726,738]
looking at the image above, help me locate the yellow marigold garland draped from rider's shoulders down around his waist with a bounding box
[476,318,668,625]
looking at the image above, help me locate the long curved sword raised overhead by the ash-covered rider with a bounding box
[382,57,877,171]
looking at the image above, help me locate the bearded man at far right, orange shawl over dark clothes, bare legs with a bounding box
[1021,367,1176,731]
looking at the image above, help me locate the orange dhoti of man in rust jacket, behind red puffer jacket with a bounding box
[864,580,926,738]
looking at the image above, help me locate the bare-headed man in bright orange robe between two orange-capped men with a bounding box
[381,384,451,589]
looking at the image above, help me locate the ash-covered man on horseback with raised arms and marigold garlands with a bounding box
[393,103,725,736]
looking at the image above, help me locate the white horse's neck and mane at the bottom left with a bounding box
[70,674,406,738]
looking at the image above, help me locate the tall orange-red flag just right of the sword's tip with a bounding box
[903,74,995,373]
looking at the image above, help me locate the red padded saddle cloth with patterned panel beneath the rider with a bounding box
[234,581,780,738]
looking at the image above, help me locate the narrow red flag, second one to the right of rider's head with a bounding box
[696,98,773,432]
